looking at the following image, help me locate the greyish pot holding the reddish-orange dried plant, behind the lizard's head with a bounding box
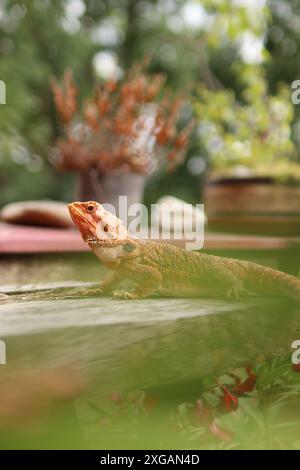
[76,169,146,214]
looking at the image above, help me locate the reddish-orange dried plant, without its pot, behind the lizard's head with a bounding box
[52,61,192,173]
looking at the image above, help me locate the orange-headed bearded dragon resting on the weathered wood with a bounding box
[68,201,300,302]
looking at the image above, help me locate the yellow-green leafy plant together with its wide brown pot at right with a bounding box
[196,66,300,235]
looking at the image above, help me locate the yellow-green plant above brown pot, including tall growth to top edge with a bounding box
[195,1,300,183]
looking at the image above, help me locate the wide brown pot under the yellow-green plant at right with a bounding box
[204,178,300,235]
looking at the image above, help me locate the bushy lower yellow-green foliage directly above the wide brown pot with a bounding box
[195,65,300,183]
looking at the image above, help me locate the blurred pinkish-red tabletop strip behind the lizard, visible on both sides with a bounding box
[0,223,300,254]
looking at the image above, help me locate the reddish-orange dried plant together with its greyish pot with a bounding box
[50,66,191,209]
